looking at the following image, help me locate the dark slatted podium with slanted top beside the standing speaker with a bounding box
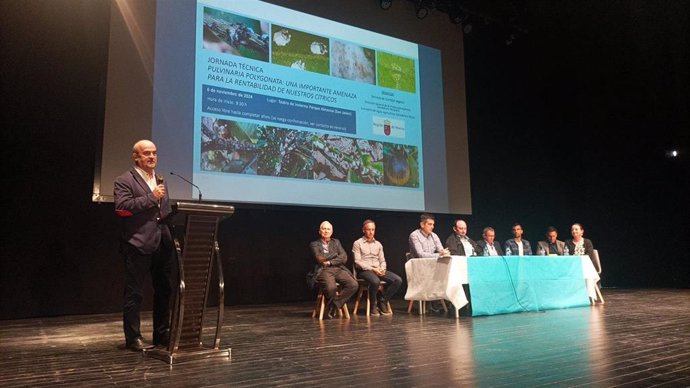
[145,202,235,365]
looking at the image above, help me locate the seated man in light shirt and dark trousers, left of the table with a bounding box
[352,220,402,315]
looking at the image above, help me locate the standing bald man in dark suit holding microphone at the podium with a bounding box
[114,140,174,351]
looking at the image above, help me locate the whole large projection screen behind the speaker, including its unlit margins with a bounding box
[92,0,464,214]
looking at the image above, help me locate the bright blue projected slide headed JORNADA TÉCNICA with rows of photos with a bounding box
[192,0,446,211]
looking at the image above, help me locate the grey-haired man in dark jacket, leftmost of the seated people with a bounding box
[309,221,359,318]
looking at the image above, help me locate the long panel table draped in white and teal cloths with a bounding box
[405,256,599,316]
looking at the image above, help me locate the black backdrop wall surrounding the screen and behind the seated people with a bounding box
[0,0,690,319]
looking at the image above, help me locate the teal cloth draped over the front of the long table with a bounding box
[467,256,590,316]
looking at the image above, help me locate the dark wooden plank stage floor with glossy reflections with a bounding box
[0,289,690,387]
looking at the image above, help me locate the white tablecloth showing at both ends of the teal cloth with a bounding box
[405,256,599,316]
